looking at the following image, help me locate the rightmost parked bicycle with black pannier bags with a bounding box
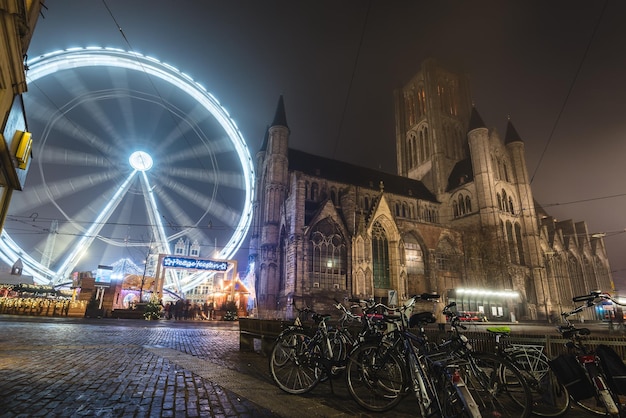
[549,291,626,417]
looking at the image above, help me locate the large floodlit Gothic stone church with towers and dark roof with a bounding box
[250,59,612,321]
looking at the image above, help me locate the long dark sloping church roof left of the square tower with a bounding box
[289,148,437,202]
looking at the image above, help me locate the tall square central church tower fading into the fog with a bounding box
[394,59,472,195]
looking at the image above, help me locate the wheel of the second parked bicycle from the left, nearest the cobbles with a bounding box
[346,343,408,412]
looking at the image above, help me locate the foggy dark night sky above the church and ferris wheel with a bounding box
[9,0,626,290]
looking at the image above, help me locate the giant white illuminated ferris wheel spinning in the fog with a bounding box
[0,48,254,293]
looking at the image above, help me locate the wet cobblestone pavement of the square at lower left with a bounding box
[0,315,596,418]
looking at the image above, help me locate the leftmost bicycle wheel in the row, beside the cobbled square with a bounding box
[269,330,323,395]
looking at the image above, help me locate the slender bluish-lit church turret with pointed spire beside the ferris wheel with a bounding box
[251,96,289,311]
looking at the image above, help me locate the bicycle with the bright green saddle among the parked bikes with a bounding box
[486,326,570,417]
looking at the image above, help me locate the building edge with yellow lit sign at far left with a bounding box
[0,0,44,231]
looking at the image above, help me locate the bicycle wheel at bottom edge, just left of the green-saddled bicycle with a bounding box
[459,353,532,418]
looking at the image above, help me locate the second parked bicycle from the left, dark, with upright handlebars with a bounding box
[346,293,488,417]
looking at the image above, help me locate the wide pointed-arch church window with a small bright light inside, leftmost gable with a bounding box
[309,218,347,290]
